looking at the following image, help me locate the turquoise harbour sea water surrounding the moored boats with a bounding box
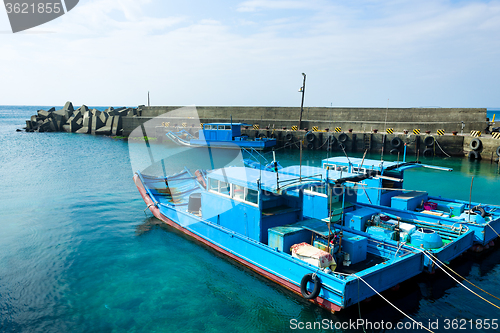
[0,106,500,332]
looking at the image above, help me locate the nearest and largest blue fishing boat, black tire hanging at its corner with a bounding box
[134,167,424,312]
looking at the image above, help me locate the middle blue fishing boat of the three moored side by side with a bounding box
[279,166,474,272]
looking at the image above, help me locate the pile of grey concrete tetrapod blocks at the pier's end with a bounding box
[25,102,137,136]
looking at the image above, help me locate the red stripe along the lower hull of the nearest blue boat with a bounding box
[134,175,342,313]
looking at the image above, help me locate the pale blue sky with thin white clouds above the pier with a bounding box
[0,0,500,108]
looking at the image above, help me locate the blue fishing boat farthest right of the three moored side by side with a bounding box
[322,157,500,248]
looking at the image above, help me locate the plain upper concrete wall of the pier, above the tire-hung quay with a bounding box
[123,106,486,135]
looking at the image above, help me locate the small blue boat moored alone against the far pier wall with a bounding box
[166,123,276,150]
